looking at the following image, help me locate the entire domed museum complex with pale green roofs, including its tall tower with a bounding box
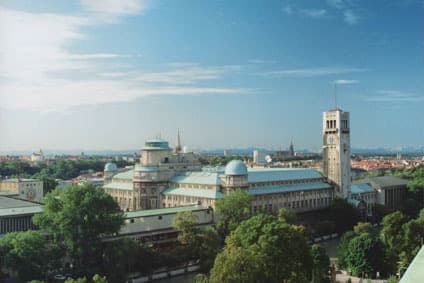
[104,109,405,215]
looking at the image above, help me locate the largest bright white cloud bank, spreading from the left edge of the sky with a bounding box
[0,6,249,112]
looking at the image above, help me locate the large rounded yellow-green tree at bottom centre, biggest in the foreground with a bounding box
[210,214,312,283]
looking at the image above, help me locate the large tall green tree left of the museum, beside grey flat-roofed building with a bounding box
[34,184,123,275]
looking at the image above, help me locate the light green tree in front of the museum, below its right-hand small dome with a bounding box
[215,189,253,236]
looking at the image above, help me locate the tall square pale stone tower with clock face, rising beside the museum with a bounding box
[323,109,351,198]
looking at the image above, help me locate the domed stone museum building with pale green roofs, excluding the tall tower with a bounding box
[104,136,333,211]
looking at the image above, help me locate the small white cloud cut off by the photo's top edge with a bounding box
[80,0,149,15]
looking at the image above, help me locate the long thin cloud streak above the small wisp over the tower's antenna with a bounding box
[262,67,369,77]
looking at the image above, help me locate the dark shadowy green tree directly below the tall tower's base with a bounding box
[330,198,361,233]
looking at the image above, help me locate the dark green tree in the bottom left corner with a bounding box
[0,231,60,281]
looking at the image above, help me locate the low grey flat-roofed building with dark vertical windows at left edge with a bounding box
[0,196,42,235]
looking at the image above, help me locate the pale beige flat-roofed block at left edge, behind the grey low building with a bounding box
[0,178,44,202]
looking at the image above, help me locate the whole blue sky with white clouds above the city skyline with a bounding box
[0,0,424,151]
